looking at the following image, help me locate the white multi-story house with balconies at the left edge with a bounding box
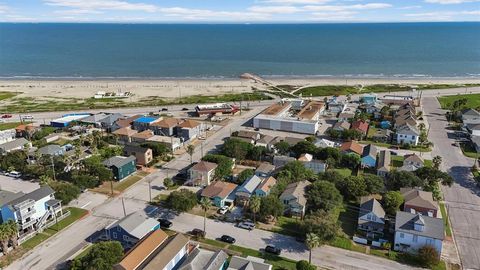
[0,186,63,238]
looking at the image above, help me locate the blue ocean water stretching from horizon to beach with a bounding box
[0,23,480,78]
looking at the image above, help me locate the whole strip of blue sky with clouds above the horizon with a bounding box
[0,0,480,23]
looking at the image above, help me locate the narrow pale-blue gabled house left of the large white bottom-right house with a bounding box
[358,196,385,238]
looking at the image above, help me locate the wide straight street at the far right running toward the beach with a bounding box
[422,97,480,269]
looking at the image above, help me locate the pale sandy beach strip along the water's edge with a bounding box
[0,77,480,101]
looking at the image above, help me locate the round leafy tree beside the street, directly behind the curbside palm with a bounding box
[301,210,340,244]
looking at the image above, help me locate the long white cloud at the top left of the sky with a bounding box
[44,0,157,12]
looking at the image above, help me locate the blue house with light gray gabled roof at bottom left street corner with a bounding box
[105,211,160,249]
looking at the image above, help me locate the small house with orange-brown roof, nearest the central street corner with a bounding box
[201,181,238,208]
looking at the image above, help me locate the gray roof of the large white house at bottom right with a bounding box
[395,211,445,240]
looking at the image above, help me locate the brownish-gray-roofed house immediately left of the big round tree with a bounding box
[280,180,311,217]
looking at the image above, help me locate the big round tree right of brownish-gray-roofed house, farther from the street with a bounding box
[305,180,343,212]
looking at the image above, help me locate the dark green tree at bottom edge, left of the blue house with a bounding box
[71,241,123,270]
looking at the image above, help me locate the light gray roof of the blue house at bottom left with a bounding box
[107,211,159,239]
